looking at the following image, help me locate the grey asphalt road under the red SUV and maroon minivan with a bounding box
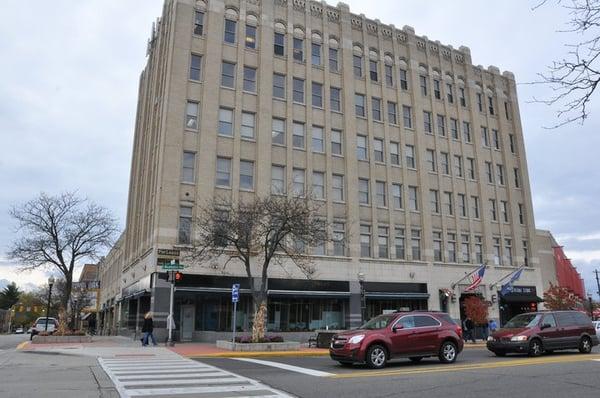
[200,347,600,398]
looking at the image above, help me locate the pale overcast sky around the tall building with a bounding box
[0,0,600,298]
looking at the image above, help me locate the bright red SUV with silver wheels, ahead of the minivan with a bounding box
[329,311,463,369]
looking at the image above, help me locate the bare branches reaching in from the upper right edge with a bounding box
[533,0,600,128]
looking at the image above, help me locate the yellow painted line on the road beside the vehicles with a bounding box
[331,355,600,379]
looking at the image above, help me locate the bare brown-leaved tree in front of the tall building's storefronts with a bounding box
[190,196,329,342]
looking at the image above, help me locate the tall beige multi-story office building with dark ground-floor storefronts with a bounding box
[103,0,542,339]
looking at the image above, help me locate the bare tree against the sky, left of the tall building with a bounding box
[8,192,117,309]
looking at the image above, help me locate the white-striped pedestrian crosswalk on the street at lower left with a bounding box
[98,355,291,398]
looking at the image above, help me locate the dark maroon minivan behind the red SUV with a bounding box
[487,311,598,357]
